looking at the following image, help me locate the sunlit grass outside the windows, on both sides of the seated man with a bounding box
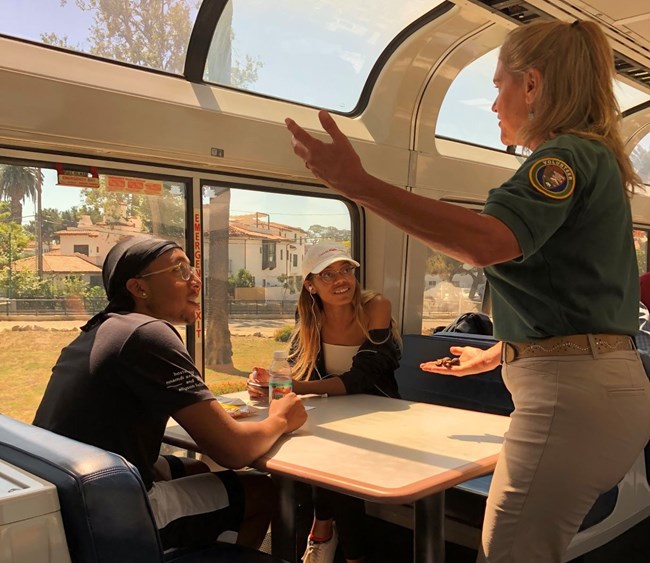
[0,330,287,422]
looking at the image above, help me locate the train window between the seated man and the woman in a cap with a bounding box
[202,183,352,392]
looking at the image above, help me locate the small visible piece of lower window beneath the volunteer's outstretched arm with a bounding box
[422,249,486,334]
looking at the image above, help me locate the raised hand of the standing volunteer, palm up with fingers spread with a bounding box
[285,110,366,196]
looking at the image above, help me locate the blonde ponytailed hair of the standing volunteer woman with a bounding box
[499,21,641,196]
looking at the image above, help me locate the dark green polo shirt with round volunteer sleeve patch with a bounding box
[483,135,639,342]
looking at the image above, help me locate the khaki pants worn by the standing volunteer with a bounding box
[478,351,650,563]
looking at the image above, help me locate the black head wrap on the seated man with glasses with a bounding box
[81,236,181,331]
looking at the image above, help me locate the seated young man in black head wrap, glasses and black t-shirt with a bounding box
[34,236,307,549]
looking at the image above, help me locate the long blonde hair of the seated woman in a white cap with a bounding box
[289,286,402,380]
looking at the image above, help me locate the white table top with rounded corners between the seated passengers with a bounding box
[168,393,510,503]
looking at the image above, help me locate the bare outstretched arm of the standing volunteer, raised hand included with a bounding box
[285,110,521,267]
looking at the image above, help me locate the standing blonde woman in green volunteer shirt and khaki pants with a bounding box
[287,21,650,563]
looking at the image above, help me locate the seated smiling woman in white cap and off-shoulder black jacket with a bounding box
[249,241,401,563]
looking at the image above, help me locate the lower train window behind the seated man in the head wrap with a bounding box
[0,164,186,422]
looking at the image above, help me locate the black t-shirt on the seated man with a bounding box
[34,313,214,489]
